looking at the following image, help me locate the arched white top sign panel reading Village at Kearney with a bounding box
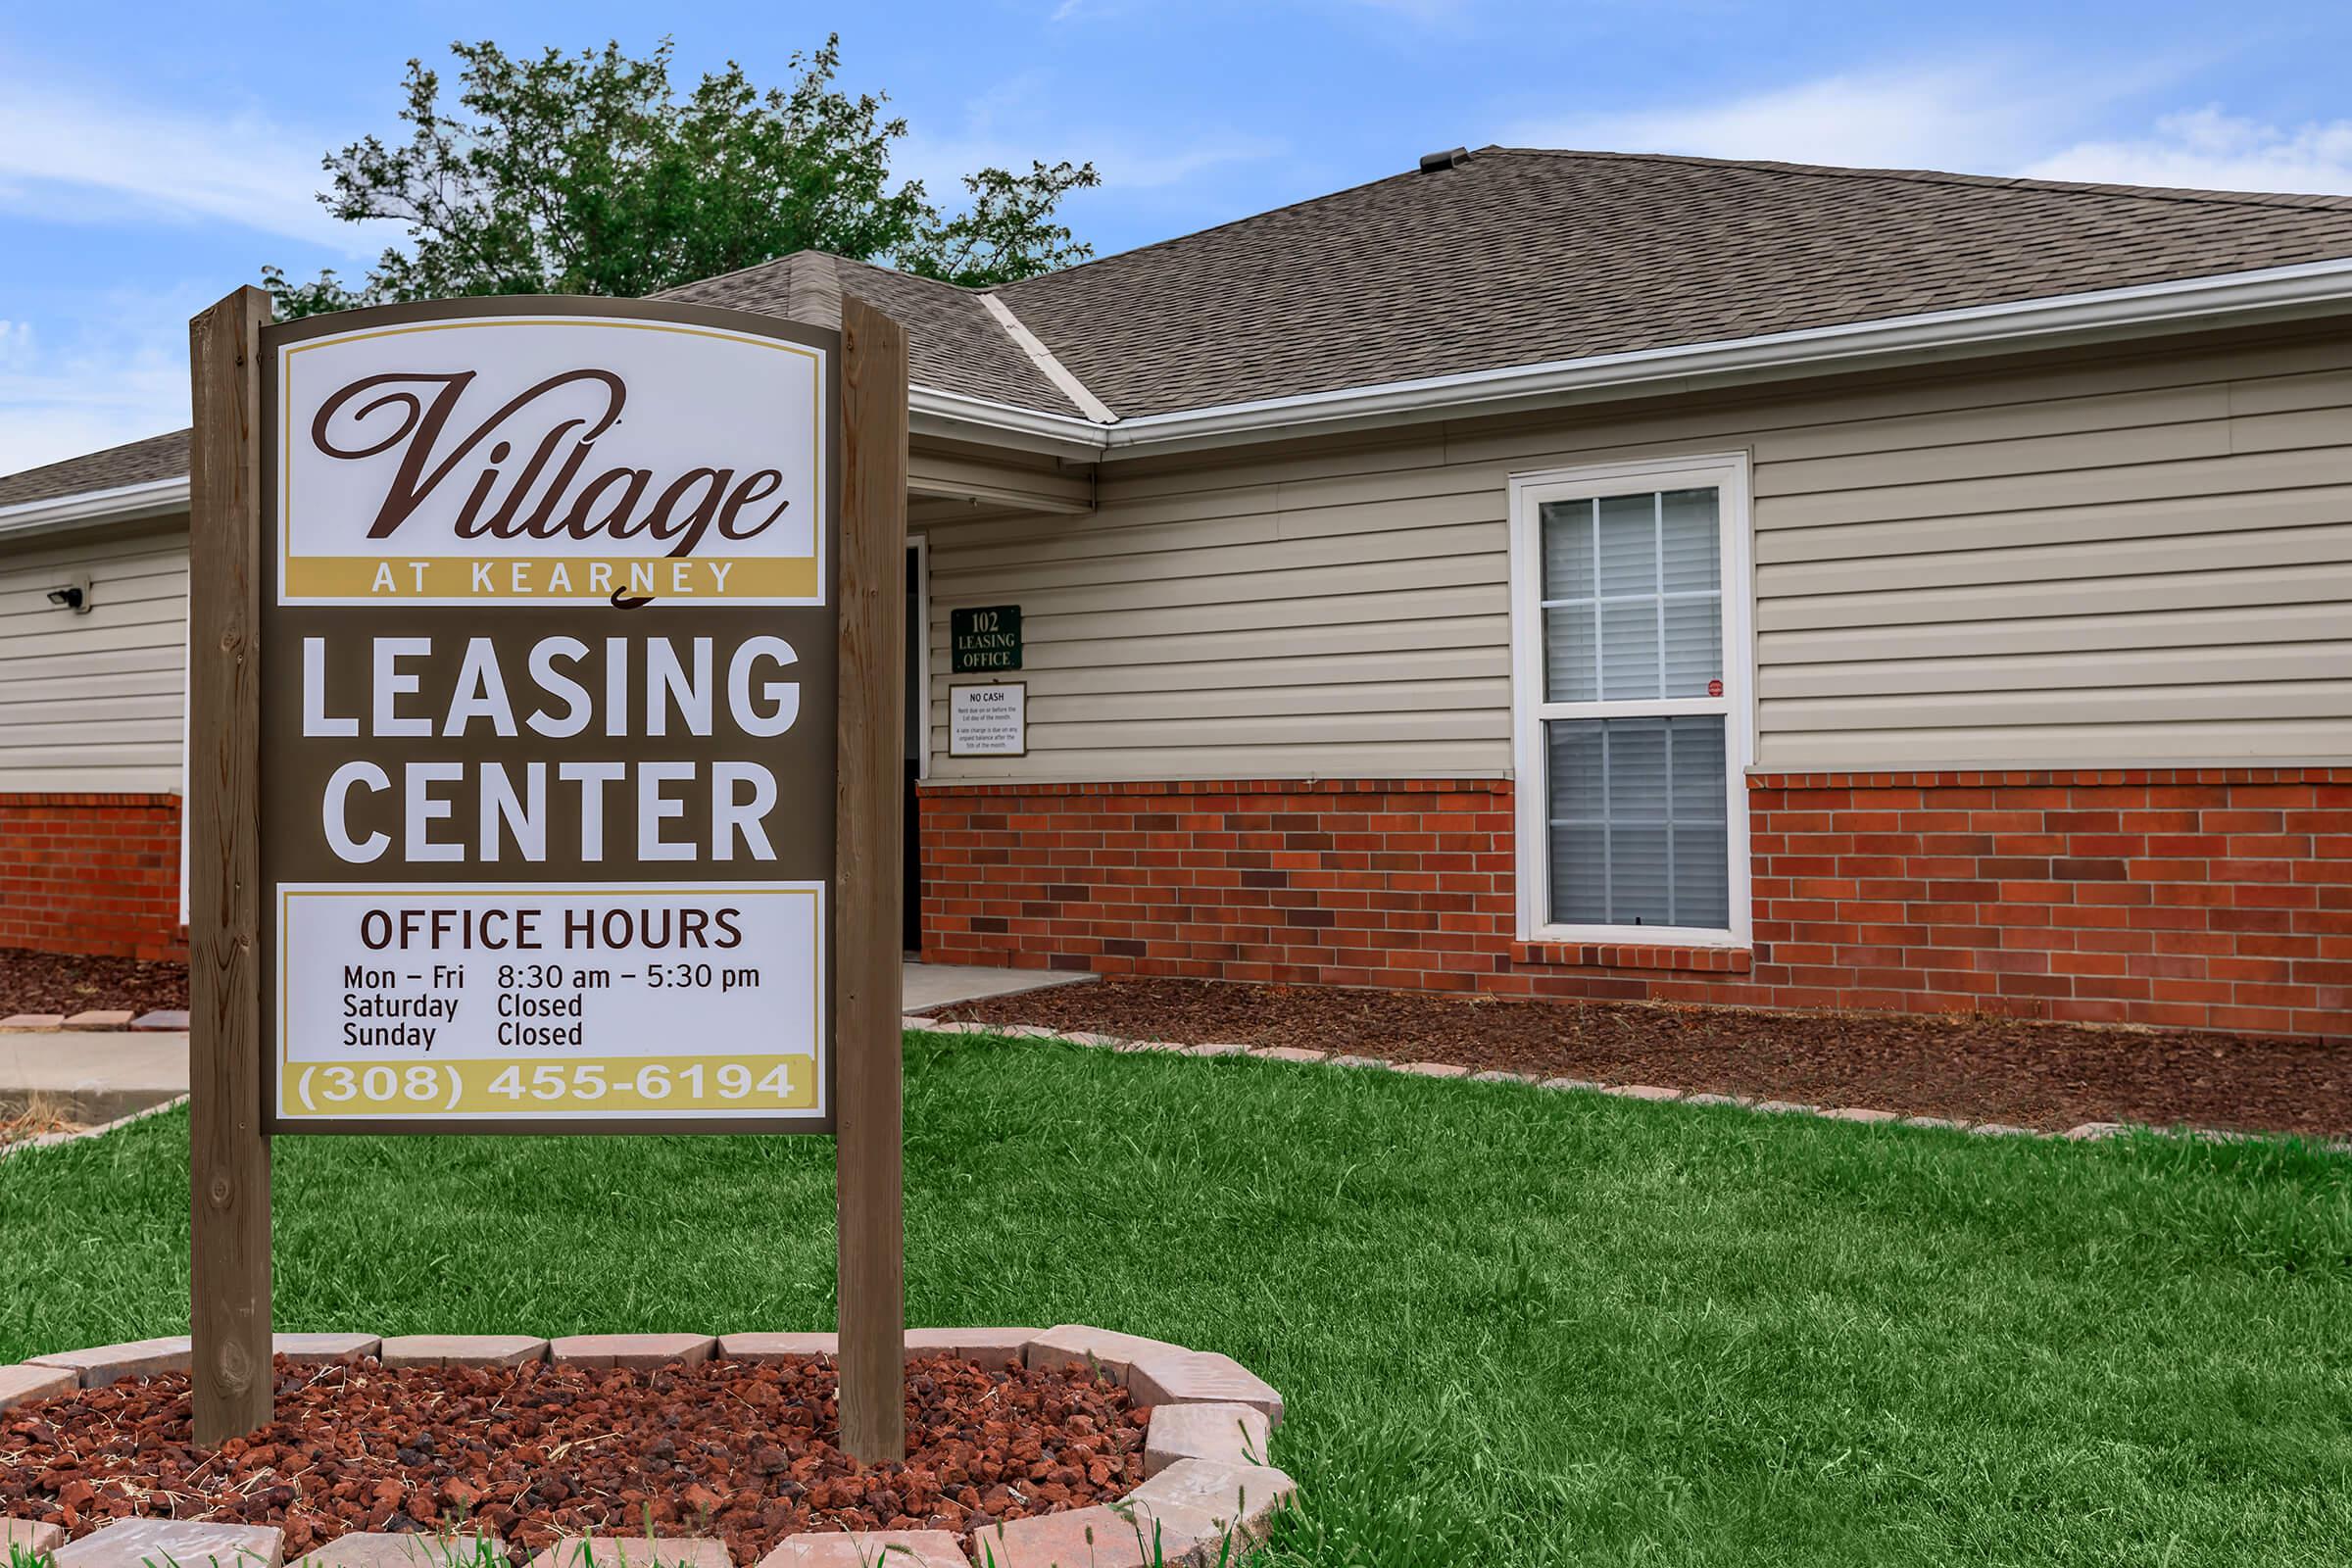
[275,315,825,604]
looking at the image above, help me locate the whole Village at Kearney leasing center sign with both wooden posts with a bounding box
[190,291,906,1457]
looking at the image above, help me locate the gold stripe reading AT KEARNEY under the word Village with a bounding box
[284,555,816,604]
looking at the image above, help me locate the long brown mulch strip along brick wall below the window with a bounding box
[934,980,2352,1136]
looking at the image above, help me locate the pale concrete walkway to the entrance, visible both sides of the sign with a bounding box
[0,964,1094,1126]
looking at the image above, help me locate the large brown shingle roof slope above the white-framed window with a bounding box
[998,148,2352,416]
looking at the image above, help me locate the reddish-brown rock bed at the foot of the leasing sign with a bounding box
[0,1356,1143,1563]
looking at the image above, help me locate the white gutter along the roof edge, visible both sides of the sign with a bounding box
[18,259,2352,534]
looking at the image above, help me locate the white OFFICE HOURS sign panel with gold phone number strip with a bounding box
[277,882,825,1124]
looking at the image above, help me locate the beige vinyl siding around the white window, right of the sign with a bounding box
[929,331,2352,780]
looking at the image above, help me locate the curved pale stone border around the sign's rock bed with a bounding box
[0,1324,1298,1568]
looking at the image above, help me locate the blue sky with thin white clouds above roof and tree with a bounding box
[0,0,2352,472]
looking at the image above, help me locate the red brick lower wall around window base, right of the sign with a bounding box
[922,768,2352,1037]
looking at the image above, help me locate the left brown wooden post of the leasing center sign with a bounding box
[181,289,272,1448]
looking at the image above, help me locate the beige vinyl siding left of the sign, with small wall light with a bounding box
[0,524,188,795]
